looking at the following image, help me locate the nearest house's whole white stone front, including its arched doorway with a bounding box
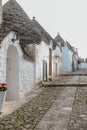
[0,32,35,100]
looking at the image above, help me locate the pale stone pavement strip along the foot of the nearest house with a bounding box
[0,87,44,118]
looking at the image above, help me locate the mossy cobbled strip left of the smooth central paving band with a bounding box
[0,87,64,130]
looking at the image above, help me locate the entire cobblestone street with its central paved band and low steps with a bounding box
[0,70,87,130]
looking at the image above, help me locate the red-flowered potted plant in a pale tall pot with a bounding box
[0,83,7,113]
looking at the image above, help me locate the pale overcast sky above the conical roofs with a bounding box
[2,0,87,58]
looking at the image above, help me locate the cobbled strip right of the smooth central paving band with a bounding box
[68,86,87,130]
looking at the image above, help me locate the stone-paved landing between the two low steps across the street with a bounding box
[43,73,87,87]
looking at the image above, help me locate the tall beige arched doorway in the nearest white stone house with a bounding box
[6,45,19,100]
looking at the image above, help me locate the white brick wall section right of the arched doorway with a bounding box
[19,55,35,97]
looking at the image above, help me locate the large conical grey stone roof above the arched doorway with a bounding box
[0,0,41,45]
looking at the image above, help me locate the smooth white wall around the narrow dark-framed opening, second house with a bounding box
[35,41,51,84]
